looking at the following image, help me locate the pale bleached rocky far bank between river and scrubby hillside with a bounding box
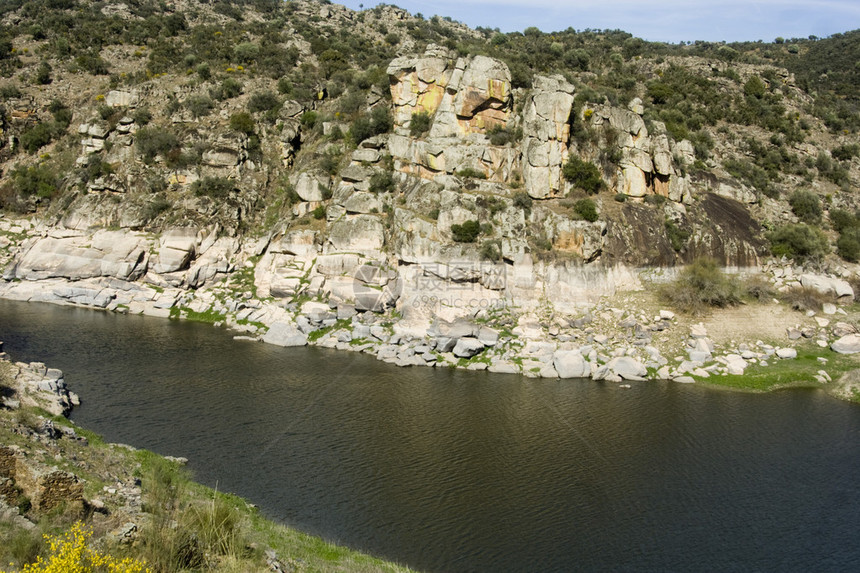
[0,213,860,397]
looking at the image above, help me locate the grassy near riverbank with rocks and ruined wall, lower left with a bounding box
[0,350,410,572]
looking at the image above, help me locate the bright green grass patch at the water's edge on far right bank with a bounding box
[694,345,860,392]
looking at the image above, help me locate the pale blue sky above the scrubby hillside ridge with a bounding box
[334,0,860,42]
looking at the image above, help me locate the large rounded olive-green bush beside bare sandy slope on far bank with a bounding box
[660,258,741,315]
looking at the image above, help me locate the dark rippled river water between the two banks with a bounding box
[0,301,860,571]
